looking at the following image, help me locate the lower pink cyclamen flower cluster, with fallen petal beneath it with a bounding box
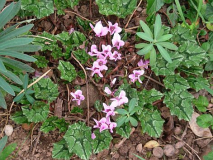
[92,87,128,139]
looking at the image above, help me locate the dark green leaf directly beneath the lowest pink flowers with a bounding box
[92,129,112,154]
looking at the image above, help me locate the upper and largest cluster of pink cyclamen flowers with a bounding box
[87,21,124,77]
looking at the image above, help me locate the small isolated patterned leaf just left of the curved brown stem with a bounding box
[58,60,77,82]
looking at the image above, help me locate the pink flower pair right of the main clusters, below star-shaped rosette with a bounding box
[129,59,149,83]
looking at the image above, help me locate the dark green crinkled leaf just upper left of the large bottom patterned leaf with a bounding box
[40,116,68,133]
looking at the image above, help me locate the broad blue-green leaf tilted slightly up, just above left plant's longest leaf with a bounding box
[0,38,33,50]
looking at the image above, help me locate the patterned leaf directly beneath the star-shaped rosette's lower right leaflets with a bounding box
[150,52,184,76]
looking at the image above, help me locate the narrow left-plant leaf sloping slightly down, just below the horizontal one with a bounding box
[0,50,37,62]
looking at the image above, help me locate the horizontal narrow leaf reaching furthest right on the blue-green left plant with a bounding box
[5,44,41,52]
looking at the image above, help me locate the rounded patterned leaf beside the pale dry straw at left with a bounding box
[33,78,59,102]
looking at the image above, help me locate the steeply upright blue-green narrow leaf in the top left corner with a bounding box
[0,3,14,29]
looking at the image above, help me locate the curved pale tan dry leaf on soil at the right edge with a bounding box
[189,112,212,137]
